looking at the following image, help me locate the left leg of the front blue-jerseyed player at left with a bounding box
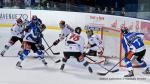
[16,42,31,68]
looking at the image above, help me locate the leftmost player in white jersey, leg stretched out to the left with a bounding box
[1,18,24,56]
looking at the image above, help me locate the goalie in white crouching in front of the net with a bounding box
[85,30,104,56]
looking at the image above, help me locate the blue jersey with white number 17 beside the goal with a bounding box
[122,32,145,53]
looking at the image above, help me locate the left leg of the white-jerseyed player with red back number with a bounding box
[60,52,72,70]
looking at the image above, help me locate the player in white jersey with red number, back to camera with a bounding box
[60,27,93,73]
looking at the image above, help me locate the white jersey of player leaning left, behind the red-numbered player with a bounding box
[59,24,74,41]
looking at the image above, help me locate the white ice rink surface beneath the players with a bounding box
[0,28,150,84]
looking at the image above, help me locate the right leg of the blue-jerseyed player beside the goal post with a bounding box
[135,50,150,74]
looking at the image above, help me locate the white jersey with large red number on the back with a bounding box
[64,33,84,53]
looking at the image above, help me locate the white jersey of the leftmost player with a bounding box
[11,24,24,38]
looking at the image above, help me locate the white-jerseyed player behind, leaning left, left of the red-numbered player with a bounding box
[53,20,74,46]
